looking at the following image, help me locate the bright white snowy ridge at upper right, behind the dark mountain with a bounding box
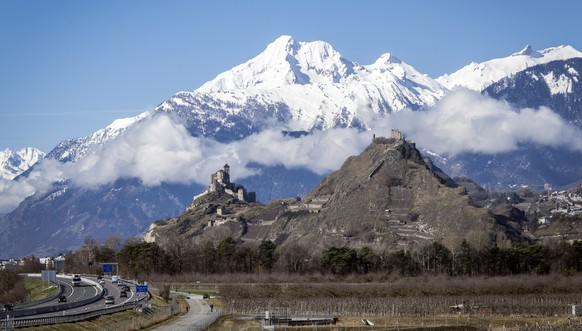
[436,45,582,91]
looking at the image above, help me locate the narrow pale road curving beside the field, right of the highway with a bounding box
[154,293,218,331]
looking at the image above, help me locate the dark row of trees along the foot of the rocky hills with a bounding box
[59,237,582,278]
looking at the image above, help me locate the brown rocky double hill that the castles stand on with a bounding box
[147,131,527,252]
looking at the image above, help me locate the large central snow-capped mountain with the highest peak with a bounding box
[156,36,447,140]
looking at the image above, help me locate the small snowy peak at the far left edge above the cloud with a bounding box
[0,147,45,180]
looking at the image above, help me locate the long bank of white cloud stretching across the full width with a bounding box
[0,90,582,213]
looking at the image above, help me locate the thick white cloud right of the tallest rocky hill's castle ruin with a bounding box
[390,89,582,154]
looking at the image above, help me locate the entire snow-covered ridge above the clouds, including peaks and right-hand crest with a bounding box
[44,36,582,161]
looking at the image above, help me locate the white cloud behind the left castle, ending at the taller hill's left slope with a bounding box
[64,116,370,186]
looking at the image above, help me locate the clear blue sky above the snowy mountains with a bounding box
[0,0,582,152]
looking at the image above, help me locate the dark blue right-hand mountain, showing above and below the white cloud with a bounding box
[436,57,582,190]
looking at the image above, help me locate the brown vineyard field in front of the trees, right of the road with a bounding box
[165,275,582,330]
